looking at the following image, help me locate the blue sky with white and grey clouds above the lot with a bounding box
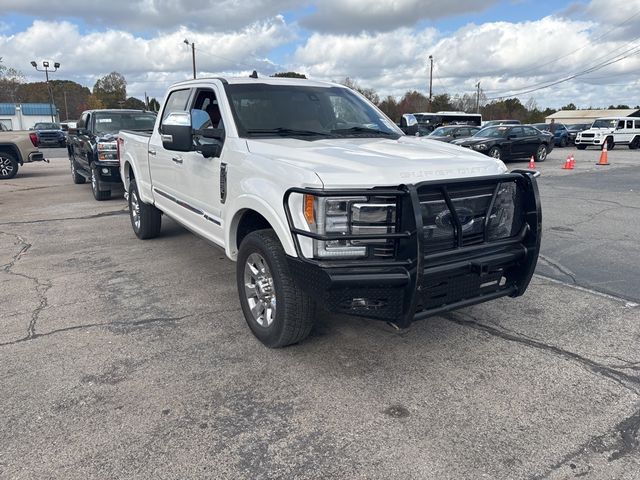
[0,0,640,107]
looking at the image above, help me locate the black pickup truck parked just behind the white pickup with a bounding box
[67,109,156,200]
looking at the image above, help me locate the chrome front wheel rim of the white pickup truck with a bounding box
[244,253,276,327]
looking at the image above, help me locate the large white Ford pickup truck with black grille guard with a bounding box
[118,78,541,347]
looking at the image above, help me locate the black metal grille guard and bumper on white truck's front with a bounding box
[284,171,542,328]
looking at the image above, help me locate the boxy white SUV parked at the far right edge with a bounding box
[576,117,640,150]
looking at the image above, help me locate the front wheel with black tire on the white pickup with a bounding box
[236,230,315,348]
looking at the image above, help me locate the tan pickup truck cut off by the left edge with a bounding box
[0,128,47,180]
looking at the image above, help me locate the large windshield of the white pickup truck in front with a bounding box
[226,84,402,140]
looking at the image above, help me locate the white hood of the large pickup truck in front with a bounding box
[247,136,507,188]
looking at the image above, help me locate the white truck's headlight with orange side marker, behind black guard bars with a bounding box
[303,195,396,258]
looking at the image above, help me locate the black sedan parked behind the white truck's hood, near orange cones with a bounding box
[451,125,553,162]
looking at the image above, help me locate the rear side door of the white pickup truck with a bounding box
[149,88,192,222]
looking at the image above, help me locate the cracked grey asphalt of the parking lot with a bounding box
[0,148,640,480]
